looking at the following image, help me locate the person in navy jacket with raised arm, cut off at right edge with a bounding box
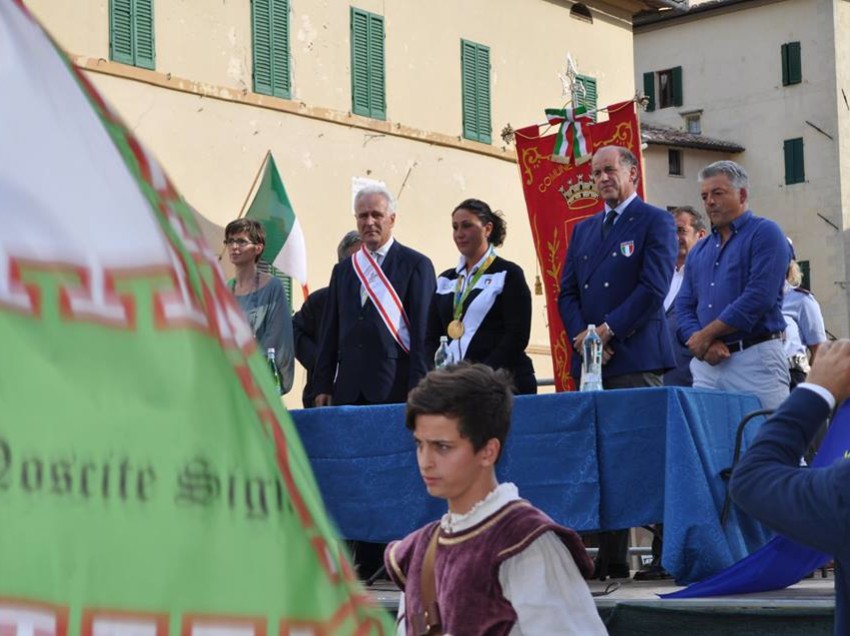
[730,340,850,635]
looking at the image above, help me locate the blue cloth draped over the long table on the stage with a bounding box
[291,388,768,583]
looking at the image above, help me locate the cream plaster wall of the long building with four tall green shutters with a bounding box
[26,0,648,407]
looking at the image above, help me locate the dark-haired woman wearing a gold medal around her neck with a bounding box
[426,199,537,394]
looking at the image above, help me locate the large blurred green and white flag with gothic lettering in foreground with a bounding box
[0,0,392,636]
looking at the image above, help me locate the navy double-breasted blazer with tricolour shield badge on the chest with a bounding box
[558,198,677,378]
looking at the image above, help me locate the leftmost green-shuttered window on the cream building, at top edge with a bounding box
[109,0,156,70]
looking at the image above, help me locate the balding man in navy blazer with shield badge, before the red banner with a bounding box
[558,146,676,578]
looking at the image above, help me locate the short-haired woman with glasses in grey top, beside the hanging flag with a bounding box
[224,219,295,394]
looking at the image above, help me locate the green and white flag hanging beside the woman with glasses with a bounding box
[245,157,308,298]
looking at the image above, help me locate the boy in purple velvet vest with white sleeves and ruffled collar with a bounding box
[384,363,607,636]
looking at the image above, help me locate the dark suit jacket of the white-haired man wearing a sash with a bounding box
[313,241,436,404]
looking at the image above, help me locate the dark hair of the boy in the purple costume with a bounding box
[404,362,514,462]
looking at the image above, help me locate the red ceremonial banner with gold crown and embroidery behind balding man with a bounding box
[516,101,643,391]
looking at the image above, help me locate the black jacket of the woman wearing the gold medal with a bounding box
[426,257,537,393]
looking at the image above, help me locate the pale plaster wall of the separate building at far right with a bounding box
[635,0,850,336]
